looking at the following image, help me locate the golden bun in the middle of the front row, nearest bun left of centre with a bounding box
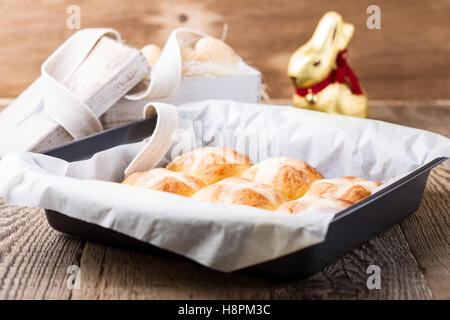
[192,178,284,210]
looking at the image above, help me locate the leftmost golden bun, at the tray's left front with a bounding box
[123,168,205,197]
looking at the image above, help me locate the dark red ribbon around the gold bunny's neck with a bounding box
[295,49,363,97]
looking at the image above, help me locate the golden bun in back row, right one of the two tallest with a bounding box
[241,158,323,200]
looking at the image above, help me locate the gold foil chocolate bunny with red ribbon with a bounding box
[288,12,368,117]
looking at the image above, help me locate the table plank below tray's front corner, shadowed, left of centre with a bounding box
[72,242,270,299]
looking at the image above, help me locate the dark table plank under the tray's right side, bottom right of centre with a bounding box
[272,225,432,299]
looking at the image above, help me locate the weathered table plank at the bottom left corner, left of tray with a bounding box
[0,200,83,300]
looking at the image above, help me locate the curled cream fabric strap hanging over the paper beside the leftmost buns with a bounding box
[125,102,178,178]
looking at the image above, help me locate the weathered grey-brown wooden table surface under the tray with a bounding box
[0,100,450,299]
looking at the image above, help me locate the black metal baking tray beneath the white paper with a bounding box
[43,119,447,280]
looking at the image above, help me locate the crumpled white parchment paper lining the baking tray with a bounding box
[0,100,450,272]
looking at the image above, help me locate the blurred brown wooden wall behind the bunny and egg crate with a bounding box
[0,0,450,99]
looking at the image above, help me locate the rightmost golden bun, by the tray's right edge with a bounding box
[305,177,381,204]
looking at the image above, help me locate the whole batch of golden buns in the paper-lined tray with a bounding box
[123,147,381,213]
